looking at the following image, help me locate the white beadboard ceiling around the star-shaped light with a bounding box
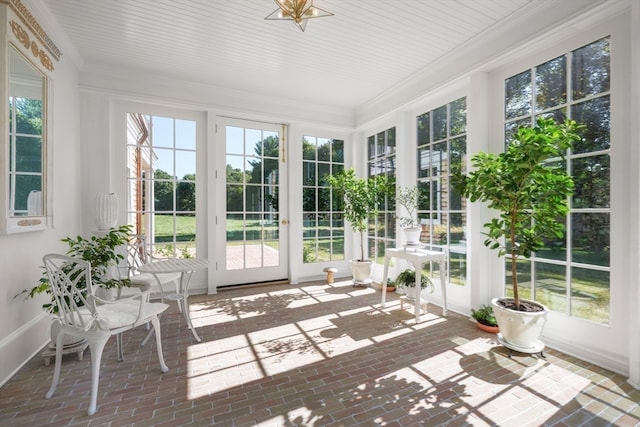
[44,0,592,108]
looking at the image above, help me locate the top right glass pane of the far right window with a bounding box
[571,37,611,100]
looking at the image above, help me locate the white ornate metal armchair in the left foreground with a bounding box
[43,254,169,415]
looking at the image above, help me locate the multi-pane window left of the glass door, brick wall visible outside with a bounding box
[127,113,196,258]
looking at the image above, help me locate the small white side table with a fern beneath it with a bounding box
[381,248,447,322]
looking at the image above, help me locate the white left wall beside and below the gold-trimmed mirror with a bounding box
[0,12,82,385]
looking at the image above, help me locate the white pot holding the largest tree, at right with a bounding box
[491,298,549,353]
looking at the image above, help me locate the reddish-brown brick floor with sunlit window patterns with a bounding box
[0,281,640,427]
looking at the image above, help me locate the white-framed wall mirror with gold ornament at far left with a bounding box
[0,0,60,233]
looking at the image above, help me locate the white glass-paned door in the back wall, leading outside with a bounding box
[215,118,289,286]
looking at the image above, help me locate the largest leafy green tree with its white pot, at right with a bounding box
[454,118,583,354]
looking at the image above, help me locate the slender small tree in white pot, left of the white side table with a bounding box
[329,168,390,286]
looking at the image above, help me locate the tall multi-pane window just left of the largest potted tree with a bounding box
[416,98,467,285]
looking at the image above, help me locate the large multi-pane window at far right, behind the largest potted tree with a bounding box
[504,37,611,324]
